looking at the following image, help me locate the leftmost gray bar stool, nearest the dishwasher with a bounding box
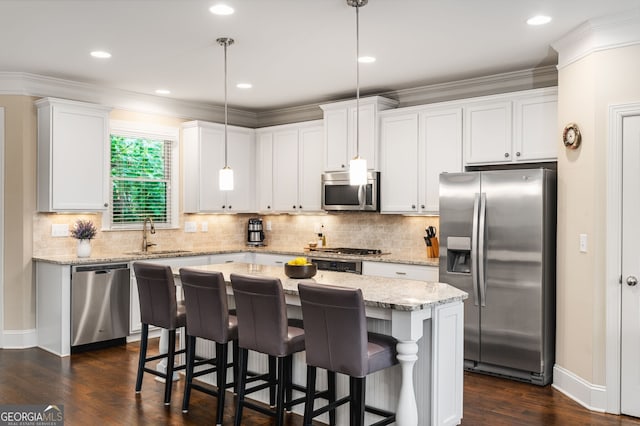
[133,262,186,405]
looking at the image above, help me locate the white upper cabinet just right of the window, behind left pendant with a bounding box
[182,121,256,213]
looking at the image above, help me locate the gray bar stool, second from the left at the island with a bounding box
[180,268,238,425]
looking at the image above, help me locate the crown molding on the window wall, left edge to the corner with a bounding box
[0,72,257,128]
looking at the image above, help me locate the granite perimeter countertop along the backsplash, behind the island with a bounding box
[33,246,439,267]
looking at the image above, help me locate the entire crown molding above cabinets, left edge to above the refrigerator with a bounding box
[0,65,558,128]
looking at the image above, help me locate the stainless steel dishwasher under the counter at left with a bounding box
[71,263,130,348]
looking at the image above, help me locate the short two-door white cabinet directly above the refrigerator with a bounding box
[464,88,558,165]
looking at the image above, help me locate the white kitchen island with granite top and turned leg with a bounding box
[174,263,467,426]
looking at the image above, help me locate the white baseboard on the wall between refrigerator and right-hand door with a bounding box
[552,364,607,413]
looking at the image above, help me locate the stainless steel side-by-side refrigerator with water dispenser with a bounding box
[440,169,556,385]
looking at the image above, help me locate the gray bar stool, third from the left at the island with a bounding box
[231,274,305,426]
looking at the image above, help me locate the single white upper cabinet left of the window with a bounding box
[35,98,111,212]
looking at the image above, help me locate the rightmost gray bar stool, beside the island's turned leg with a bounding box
[298,283,398,426]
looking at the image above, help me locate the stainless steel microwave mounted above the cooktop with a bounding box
[322,172,380,212]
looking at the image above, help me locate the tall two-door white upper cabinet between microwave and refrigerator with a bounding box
[380,103,462,213]
